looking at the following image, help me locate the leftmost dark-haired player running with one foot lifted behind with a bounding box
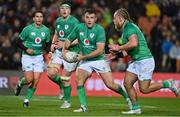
[14,11,51,107]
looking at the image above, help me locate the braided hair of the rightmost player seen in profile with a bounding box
[116,8,133,22]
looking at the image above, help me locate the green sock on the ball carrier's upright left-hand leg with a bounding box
[77,86,87,107]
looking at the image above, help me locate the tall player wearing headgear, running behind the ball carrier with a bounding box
[47,3,79,108]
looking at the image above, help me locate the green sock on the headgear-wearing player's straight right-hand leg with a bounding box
[64,85,72,102]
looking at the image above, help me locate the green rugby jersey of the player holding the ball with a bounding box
[68,23,106,61]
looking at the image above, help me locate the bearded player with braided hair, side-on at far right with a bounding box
[109,8,179,114]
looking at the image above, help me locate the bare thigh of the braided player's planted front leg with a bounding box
[124,71,138,88]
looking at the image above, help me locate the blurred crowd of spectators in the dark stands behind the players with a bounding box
[0,0,180,72]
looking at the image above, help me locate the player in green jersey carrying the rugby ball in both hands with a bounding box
[63,9,131,112]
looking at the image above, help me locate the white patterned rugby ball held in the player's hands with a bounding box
[65,51,78,63]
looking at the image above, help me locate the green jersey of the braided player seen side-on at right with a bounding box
[122,21,152,61]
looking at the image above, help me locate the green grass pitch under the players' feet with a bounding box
[0,96,180,116]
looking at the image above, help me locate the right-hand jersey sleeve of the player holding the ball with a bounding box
[96,27,106,43]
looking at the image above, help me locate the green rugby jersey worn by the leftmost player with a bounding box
[19,23,50,55]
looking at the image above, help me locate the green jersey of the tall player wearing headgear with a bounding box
[55,15,79,51]
